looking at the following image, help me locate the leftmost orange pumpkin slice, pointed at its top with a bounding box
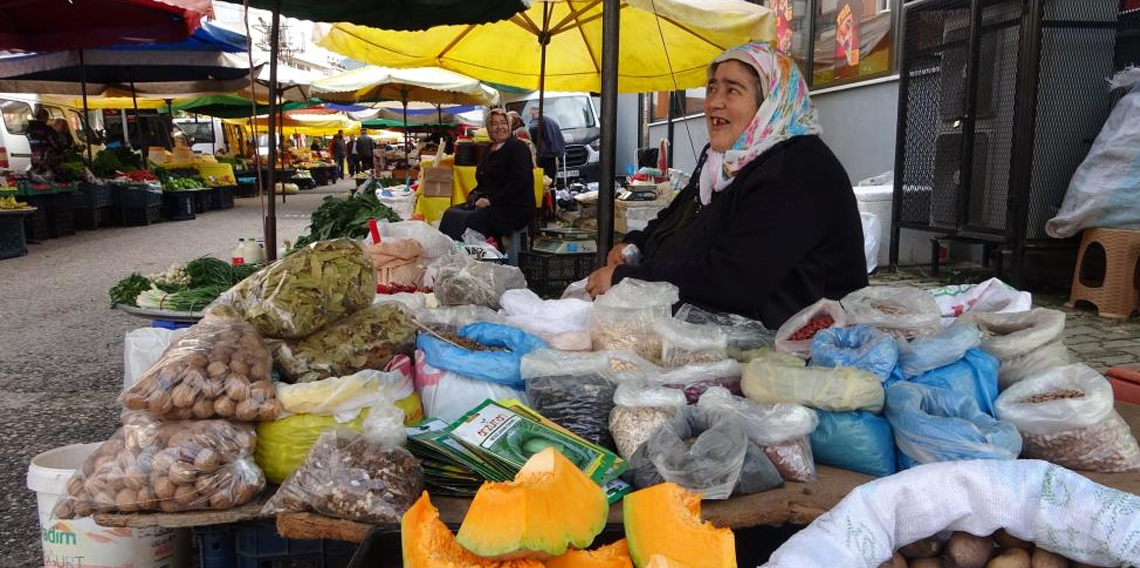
[400,492,543,568]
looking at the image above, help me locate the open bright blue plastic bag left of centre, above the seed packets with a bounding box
[416,323,546,390]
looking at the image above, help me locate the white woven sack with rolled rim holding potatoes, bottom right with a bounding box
[764,460,1140,568]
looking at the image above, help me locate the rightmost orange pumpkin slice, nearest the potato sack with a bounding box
[624,484,736,568]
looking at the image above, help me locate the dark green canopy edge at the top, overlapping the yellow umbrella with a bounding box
[240,0,527,30]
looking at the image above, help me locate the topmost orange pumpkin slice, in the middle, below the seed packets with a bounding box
[456,448,610,560]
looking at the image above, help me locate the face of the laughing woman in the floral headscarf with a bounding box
[705,59,760,152]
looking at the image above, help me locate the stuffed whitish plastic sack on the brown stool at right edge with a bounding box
[1045,67,1140,238]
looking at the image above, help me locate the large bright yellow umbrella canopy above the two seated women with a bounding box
[316,0,775,92]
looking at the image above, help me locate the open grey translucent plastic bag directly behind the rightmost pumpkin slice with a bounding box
[628,406,783,500]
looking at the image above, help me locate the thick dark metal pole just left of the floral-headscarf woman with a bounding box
[597,0,621,266]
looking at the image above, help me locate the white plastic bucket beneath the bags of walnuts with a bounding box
[27,444,185,568]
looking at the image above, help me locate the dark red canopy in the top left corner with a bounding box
[0,0,213,51]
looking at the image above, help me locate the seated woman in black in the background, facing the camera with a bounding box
[439,108,535,241]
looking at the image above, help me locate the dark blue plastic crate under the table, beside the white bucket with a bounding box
[194,520,357,568]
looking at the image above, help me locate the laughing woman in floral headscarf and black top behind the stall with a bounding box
[587,43,868,328]
